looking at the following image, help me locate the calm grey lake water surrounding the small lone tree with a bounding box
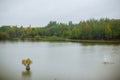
[0,41,120,80]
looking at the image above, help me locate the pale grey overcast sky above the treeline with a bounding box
[0,0,120,26]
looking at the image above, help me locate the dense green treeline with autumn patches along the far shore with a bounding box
[0,18,120,40]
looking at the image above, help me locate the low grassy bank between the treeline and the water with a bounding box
[3,36,120,43]
